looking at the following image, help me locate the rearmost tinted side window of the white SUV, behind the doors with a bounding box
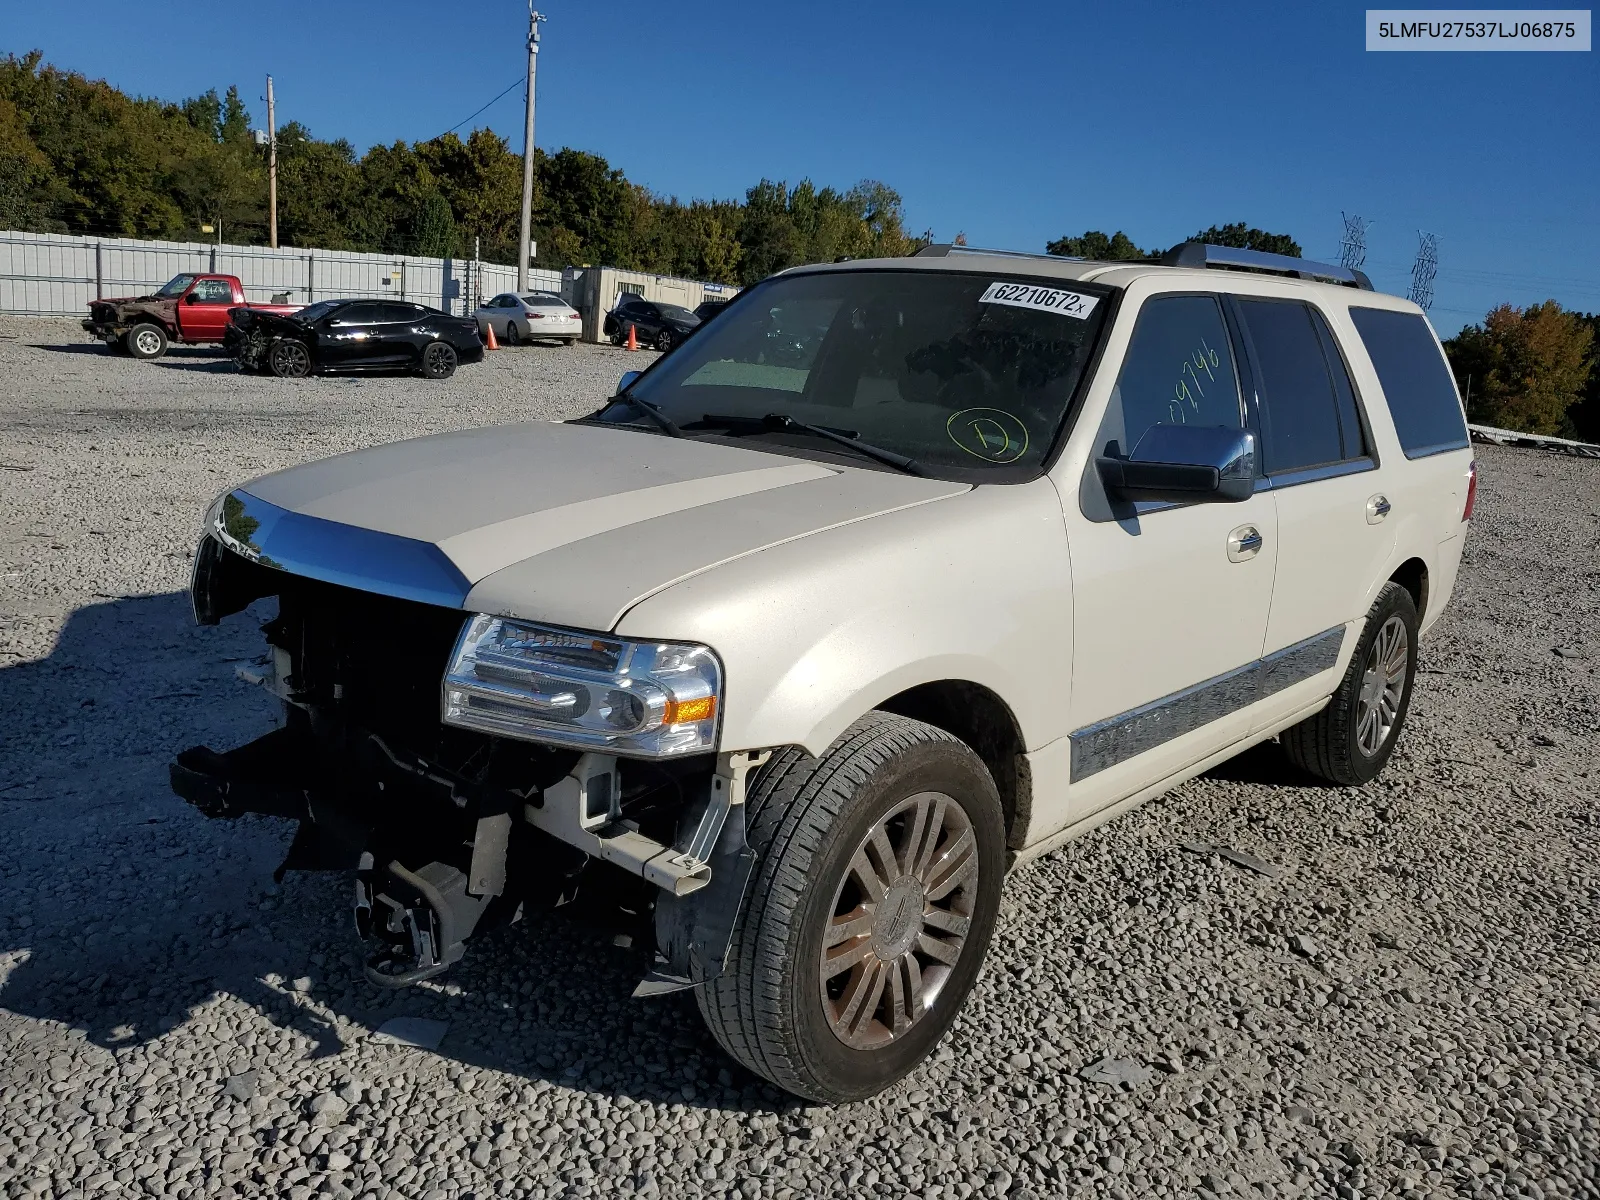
[1350,307,1469,458]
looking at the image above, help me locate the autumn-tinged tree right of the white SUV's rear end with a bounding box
[1445,301,1595,435]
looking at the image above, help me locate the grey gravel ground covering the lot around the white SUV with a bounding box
[0,318,1600,1200]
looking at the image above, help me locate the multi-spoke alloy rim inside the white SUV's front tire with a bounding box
[821,792,979,1050]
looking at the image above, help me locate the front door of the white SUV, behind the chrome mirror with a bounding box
[1064,294,1278,819]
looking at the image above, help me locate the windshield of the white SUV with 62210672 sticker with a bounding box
[602,270,1109,482]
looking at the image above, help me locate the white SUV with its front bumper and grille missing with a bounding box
[173,245,1475,1101]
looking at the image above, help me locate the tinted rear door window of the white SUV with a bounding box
[1238,299,1344,474]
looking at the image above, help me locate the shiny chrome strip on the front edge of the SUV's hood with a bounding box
[206,491,472,608]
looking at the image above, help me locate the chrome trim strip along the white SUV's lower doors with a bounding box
[1069,626,1344,782]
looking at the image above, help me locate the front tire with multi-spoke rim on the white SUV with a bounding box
[698,712,1005,1104]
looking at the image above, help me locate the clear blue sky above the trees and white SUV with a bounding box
[0,0,1600,336]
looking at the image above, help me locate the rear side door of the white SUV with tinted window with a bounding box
[1237,296,1395,728]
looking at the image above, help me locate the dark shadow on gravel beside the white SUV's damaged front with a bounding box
[0,592,784,1109]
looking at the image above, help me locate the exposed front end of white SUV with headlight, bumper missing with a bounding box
[171,569,748,986]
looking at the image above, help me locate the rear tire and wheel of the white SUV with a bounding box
[1278,582,1418,787]
